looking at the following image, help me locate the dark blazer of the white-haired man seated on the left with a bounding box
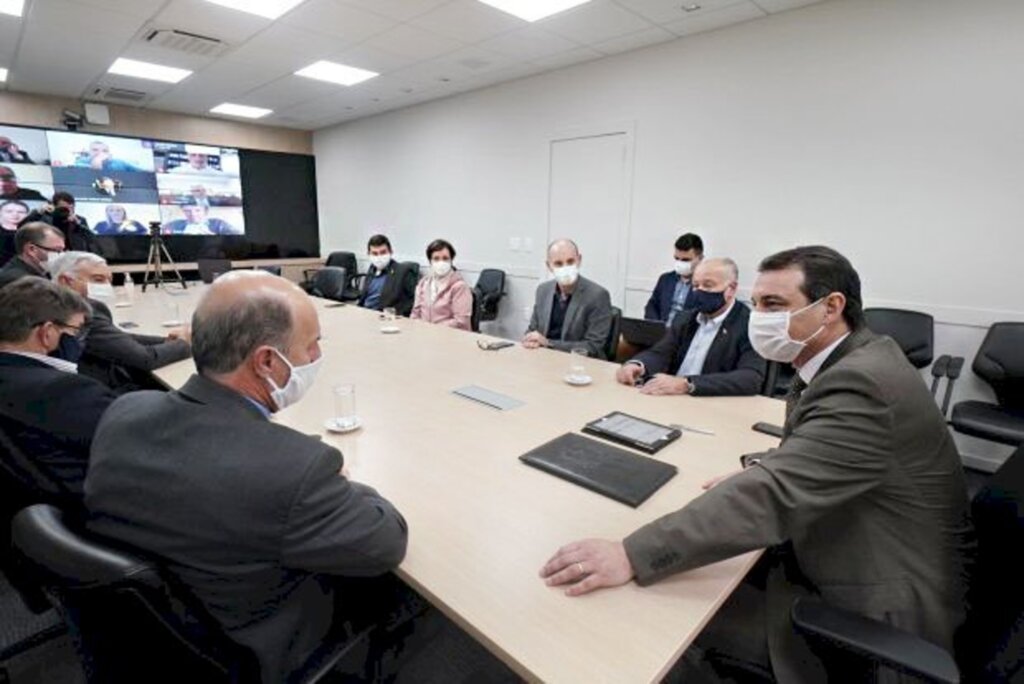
[79,299,191,389]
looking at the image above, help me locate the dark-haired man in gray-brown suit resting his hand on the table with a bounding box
[541,247,974,682]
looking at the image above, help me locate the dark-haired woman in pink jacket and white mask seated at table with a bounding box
[409,240,473,330]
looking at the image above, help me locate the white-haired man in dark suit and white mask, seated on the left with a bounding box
[50,252,191,392]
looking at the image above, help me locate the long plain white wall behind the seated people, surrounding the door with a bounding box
[314,0,1024,466]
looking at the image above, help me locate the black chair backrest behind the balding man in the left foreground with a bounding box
[11,504,258,684]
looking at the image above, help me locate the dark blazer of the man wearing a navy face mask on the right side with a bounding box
[631,301,766,396]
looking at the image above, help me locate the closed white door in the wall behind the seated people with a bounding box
[548,132,629,307]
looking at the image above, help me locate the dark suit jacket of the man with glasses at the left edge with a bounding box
[0,352,117,500]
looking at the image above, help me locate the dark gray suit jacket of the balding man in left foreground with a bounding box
[85,376,407,683]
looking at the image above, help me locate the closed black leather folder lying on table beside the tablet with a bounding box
[519,432,678,508]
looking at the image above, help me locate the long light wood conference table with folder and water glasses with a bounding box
[113,285,783,683]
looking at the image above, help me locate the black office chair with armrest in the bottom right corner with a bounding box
[793,447,1024,684]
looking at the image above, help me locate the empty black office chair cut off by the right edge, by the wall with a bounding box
[949,323,1024,446]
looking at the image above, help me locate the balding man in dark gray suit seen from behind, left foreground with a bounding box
[85,271,408,683]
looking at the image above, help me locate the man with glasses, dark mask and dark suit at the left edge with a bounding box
[0,277,116,504]
